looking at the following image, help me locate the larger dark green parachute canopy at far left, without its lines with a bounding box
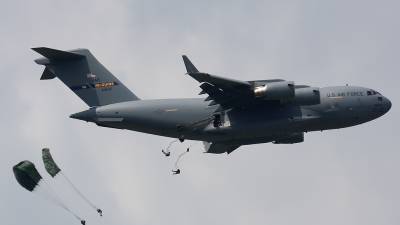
[13,160,42,191]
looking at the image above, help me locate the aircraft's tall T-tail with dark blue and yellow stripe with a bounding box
[32,47,139,107]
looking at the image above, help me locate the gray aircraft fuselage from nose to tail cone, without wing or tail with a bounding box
[71,86,391,145]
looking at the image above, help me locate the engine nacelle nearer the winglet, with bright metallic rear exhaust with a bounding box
[254,81,295,100]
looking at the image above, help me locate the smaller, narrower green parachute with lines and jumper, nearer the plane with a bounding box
[42,148,103,216]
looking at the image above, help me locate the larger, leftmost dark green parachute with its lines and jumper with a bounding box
[13,160,84,223]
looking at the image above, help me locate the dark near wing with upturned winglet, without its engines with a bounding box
[182,55,283,112]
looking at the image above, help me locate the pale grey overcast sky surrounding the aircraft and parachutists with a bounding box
[0,0,400,225]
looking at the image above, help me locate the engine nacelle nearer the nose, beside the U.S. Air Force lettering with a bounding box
[289,87,321,106]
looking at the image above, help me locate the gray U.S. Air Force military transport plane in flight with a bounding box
[33,47,392,154]
